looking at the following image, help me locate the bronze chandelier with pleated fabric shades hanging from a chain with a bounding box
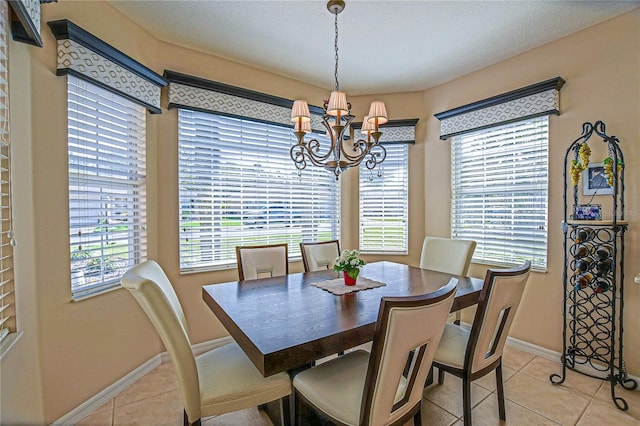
[290,0,387,180]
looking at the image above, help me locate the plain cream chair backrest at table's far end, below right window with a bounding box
[420,237,476,275]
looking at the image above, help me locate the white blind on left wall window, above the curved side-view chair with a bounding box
[68,75,147,298]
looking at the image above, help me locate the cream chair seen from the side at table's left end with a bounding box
[120,260,291,425]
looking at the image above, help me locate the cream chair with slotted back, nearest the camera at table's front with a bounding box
[293,281,456,425]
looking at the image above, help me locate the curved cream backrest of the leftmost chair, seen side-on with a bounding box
[120,260,201,419]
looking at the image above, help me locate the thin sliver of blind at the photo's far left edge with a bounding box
[0,1,16,341]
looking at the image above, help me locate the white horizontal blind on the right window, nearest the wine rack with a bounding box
[451,116,549,270]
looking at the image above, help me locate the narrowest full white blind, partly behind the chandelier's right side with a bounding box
[360,144,409,254]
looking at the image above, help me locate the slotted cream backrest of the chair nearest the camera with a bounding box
[360,280,457,425]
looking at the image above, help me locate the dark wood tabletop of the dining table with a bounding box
[202,262,483,377]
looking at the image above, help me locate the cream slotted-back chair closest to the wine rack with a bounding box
[433,261,531,426]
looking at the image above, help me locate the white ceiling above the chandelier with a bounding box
[109,0,640,95]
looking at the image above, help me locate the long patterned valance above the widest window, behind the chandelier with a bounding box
[164,70,324,130]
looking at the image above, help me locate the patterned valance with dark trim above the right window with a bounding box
[435,77,564,139]
